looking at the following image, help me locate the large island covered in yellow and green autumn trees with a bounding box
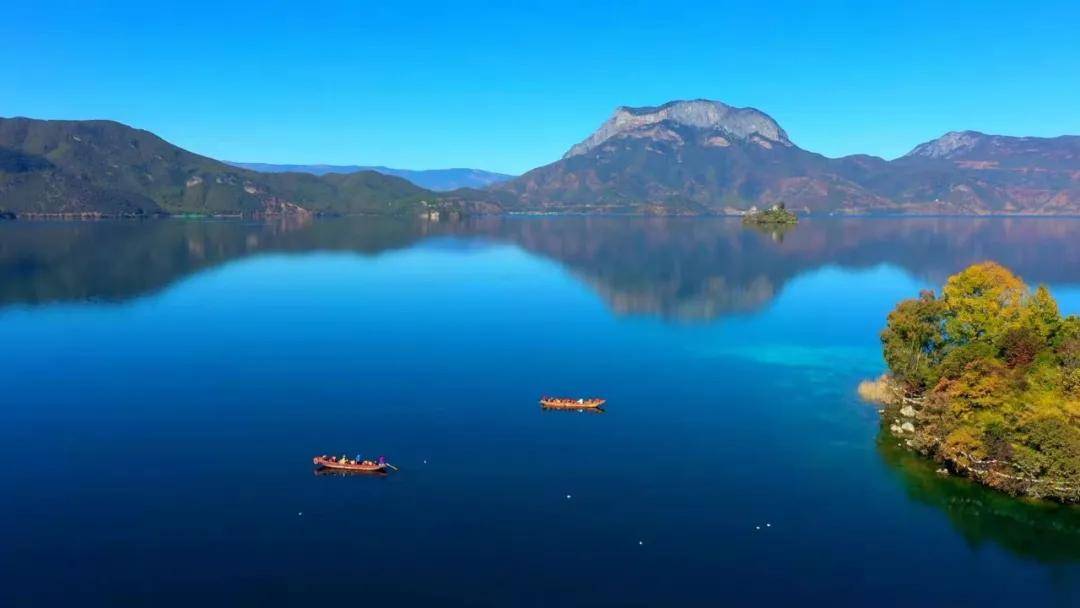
[860,261,1080,502]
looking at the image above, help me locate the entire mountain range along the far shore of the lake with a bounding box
[0,99,1080,216]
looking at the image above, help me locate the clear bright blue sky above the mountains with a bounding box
[0,0,1080,173]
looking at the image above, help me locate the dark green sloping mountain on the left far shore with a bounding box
[0,118,437,215]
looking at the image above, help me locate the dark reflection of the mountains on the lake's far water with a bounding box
[0,216,1080,321]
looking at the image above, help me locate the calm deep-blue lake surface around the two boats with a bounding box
[0,217,1080,606]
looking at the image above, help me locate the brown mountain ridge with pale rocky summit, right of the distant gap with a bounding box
[492,99,1080,215]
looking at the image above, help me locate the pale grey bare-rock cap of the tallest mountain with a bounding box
[563,99,792,159]
